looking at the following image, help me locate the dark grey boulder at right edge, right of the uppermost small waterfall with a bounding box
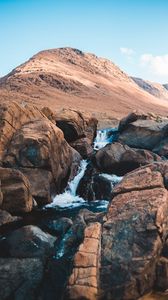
[119,115,168,155]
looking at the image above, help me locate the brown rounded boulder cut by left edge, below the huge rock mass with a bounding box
[0,167,33,213]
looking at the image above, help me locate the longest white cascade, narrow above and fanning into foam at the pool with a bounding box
[46,160,88,208]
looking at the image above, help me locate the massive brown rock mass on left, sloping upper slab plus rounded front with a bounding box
[0,103,73,204]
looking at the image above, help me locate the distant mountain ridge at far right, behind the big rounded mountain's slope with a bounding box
[132,77,168,100]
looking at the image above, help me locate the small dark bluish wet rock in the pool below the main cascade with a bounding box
[46,217,73,236]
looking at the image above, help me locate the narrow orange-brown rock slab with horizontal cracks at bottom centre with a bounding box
[65,222,101,300]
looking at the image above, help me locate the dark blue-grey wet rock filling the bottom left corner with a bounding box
[0,258,44,300]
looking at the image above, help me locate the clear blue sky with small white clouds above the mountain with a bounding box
[0,0,168,83]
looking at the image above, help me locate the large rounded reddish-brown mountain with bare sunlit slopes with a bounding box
[0,48,168,124]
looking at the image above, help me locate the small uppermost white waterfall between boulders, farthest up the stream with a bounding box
[94,128,117,150]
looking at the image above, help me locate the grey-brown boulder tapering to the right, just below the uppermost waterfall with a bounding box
[95,142,161,176]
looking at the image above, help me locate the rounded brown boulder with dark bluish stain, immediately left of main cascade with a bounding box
[4,118,72,203]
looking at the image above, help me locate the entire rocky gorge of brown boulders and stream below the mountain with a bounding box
[0,102,168,300]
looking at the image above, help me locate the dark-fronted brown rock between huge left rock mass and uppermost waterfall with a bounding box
[56,109,98,158]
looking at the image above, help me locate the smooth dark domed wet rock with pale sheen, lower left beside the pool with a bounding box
[4,225,56,259]
